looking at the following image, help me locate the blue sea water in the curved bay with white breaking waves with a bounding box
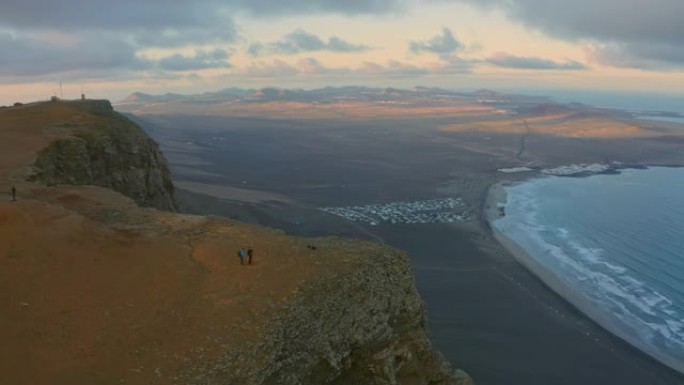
[494,168,684,371]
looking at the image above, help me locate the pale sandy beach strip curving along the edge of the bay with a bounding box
[483,183,682,383]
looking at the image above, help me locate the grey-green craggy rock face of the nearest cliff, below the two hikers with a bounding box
[183,241,473,385]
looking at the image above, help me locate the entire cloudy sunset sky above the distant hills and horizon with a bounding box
[0,0,684,105]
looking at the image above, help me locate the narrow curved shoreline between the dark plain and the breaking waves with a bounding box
[482,179,684,374]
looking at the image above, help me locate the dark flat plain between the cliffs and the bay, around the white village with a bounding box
[128,109,684,385]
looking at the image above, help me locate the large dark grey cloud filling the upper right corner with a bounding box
[448,0,684,68]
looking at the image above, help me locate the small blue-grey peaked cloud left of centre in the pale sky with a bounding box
[247,29,370,56]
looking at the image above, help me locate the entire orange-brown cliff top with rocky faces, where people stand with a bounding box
[0,102,472,385]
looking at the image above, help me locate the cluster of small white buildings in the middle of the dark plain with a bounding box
[321,198,473,226]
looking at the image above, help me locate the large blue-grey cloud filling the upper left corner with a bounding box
[0,0,238,47]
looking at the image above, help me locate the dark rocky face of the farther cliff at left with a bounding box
[29,101,177,211]
